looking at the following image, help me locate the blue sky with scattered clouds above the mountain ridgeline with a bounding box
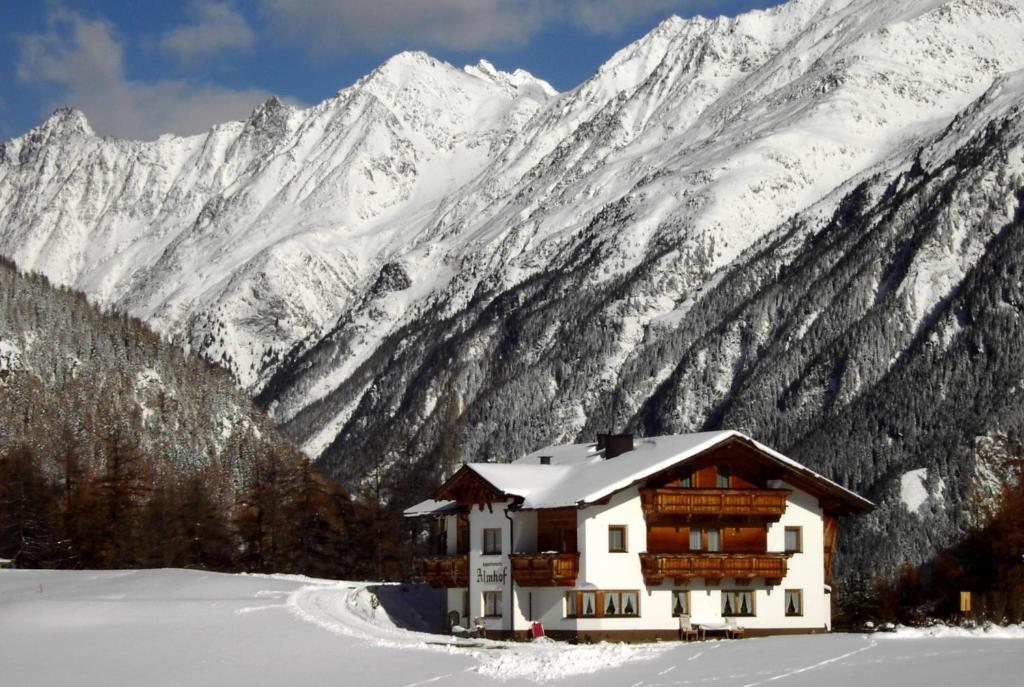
[0,0,779,139]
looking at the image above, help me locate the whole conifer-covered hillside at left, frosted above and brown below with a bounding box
[0,258,408,578]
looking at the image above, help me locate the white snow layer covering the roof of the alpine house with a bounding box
[406,431,873,516]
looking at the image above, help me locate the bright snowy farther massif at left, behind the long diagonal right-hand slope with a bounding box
[0,53,554,387]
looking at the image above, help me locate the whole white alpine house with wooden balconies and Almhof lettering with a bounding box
[407,432,872,640]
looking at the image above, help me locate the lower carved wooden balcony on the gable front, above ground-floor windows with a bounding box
[640,552,788,585]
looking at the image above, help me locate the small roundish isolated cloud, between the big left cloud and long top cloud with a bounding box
[160,0,256,62]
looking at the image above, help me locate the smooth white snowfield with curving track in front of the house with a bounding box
[0,570,1024,687]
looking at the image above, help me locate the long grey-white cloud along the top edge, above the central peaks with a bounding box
[256,0,709,53]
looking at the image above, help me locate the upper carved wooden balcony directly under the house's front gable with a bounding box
[640,487,791,522]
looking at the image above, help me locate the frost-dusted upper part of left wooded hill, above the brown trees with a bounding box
[0,250,293,479]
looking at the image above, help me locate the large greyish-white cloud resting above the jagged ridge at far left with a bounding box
[16,9,288,139]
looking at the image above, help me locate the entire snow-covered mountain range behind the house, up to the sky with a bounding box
[0,0,1024,577]
